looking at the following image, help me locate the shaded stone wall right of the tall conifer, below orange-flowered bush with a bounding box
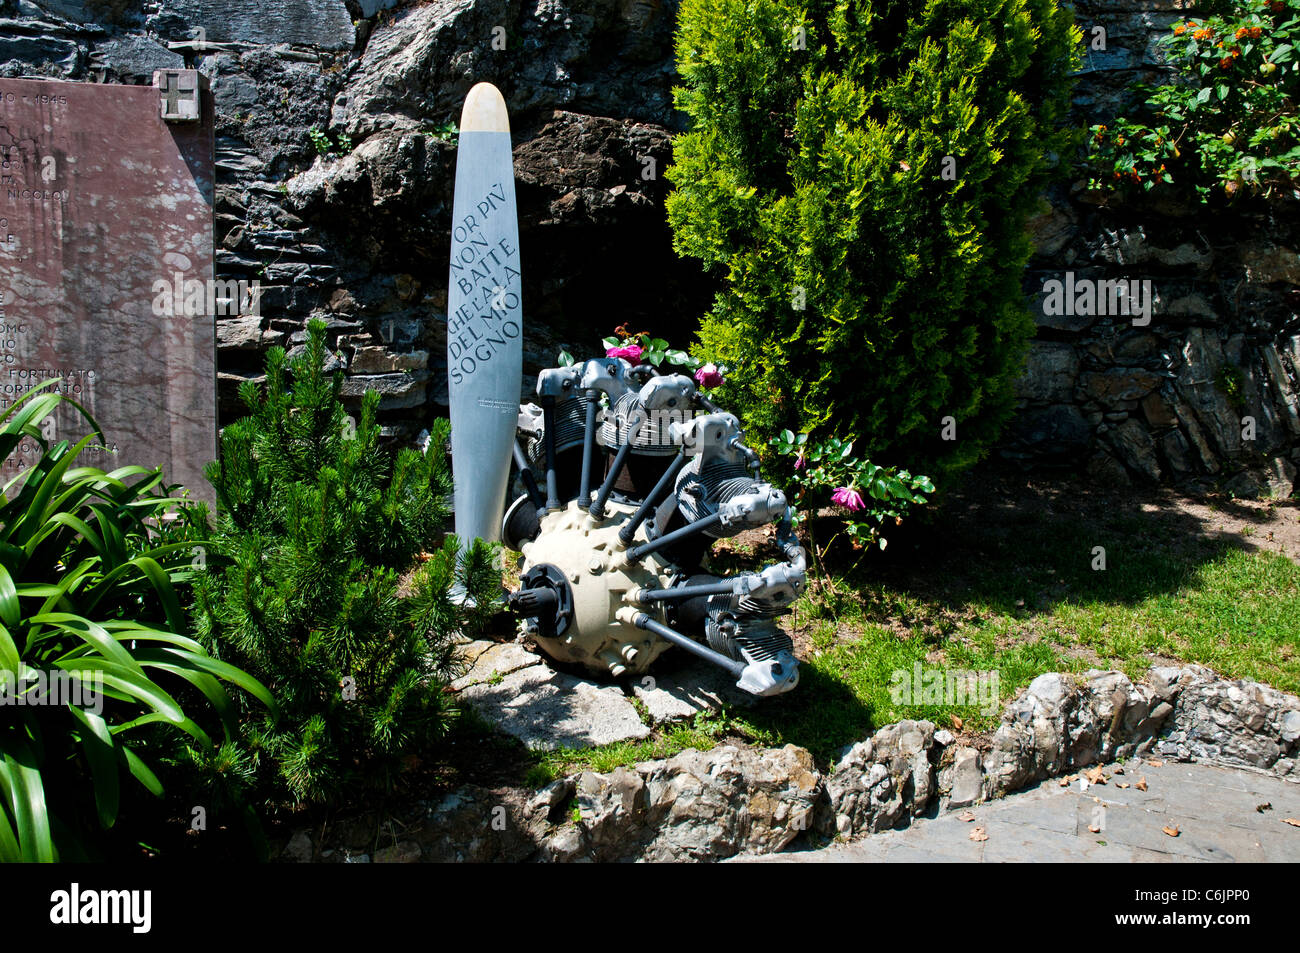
[1000,0,1300,495]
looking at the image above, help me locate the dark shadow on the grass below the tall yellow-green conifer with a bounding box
[795,468,1296,627]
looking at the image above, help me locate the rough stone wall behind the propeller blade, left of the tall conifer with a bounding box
[0,0,712,438]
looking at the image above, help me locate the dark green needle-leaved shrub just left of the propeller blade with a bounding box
[196,321,501,802]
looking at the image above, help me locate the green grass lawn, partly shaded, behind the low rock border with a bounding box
[449,475,1300,784]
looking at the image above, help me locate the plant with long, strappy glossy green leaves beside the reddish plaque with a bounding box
[0,387,272,862]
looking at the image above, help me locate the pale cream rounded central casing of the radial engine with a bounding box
[521,499,679,676]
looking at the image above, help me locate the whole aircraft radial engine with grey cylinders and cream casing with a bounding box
[502,358,807,696]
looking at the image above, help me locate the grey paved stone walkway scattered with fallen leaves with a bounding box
[737,761,1300,863]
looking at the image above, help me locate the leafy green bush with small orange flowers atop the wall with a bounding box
[1089,0,1300,202]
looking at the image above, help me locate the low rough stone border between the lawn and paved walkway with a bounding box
[287,666,1300,862]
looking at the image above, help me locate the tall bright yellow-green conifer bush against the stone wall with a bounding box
[668,0,1080,477]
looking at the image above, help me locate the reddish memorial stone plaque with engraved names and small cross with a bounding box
[0,70,215,501]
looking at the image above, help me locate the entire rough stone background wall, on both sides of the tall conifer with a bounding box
[0,0,1300,494]
